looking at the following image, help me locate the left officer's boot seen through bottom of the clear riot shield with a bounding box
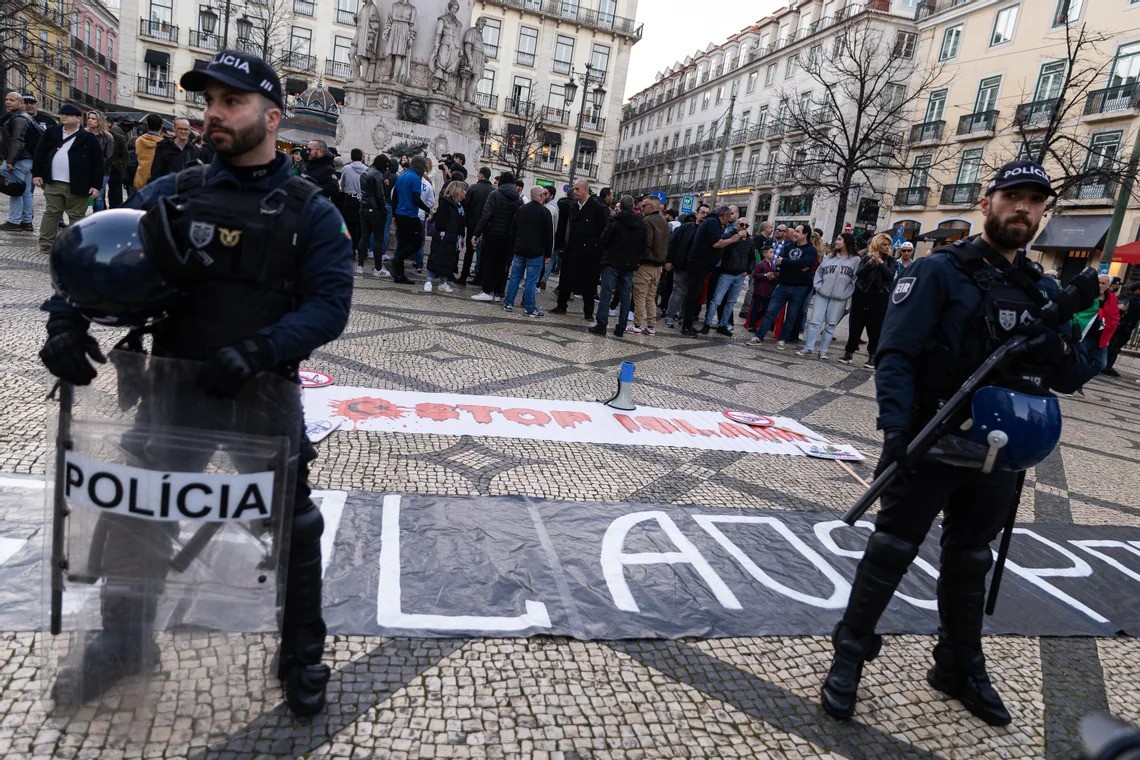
[51,596,157,706]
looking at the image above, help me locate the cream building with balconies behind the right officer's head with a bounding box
[884,0,1140,279]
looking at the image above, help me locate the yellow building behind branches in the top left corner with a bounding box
[2,0,73,114]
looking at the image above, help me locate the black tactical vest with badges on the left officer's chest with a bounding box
[153,166,320,369]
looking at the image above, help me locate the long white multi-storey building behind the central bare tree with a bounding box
[614,0,918,238]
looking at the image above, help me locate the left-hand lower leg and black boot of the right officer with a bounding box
[820,531,919,720]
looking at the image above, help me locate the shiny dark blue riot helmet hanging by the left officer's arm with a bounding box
[51,209,179,326]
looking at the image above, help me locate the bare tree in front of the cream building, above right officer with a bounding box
[986,18,1140,210]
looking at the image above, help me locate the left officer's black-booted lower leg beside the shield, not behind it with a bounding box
[277,501,332,716]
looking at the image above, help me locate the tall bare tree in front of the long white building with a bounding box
[776,11,948,240]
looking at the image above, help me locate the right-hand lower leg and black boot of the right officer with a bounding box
[927,547,1012,726]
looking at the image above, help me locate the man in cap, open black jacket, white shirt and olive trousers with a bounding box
[32,103,103,253]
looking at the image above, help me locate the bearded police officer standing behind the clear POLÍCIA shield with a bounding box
[40,50,352,714]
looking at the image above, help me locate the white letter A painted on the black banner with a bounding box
[601,510,743,612]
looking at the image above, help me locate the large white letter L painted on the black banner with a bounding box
[376,495,551,634]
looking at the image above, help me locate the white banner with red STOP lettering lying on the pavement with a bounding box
[301,386,829,457]
